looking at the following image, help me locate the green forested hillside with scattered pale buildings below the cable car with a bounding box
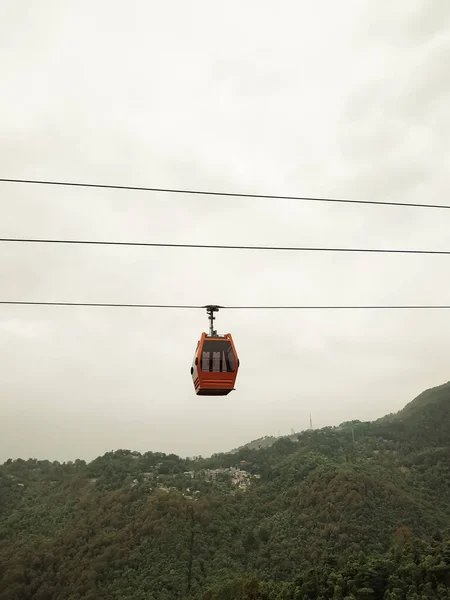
[0,383,450,600]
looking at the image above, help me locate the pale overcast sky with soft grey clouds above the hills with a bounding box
[0,0,450,461]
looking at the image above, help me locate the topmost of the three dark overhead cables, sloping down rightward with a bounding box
[0,177,450,209]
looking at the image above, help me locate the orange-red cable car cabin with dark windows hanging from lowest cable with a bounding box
[191,306,239,396]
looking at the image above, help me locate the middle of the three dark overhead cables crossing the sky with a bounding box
[0,238,450,255]
